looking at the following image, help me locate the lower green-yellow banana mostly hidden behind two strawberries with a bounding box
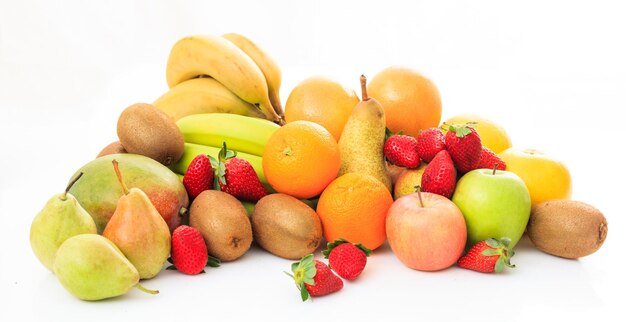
[170,143,273,187]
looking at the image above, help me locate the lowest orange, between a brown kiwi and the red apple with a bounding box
[317,172,393,249]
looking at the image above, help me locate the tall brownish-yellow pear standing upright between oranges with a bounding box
[338,75,391,191]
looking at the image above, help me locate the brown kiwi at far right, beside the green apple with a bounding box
[526,200,608,259]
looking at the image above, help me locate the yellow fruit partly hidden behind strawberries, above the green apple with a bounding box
[445,114,512,153]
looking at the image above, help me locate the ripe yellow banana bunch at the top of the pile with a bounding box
[154,33,284,125]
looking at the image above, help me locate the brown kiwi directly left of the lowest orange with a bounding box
[250,193,322,259]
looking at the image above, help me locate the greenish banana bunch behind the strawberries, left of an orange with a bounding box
[172,113,280,187]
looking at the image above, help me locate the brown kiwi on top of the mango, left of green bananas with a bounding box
[117,103,185,166]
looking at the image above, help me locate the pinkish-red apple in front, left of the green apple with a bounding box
[386,192,467,271]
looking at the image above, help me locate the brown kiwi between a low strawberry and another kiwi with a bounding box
[189,190,252,262]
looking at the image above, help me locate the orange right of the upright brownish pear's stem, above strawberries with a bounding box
[367,67,441,137]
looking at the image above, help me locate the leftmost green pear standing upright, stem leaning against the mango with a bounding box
[30,172,97,271]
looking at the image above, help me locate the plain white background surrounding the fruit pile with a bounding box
[0,0,626,321]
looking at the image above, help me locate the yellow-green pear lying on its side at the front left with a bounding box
[53,234,158,301]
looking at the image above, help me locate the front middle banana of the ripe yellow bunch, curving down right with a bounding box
[166,35,284,124]
